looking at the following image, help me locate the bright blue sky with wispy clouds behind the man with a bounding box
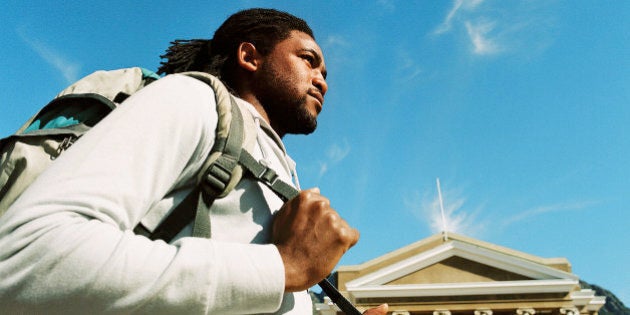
[0,0,630,303]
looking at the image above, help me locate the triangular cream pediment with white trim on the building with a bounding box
[345,239,579,298]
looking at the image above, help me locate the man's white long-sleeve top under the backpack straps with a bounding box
[0,75,311,314]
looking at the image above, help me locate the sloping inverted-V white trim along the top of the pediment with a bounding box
[346,240,579,287]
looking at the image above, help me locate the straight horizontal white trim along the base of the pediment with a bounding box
[347,279,578,298]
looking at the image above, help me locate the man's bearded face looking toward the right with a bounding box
[254,31,328,136]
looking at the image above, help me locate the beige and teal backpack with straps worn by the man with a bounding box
[0,67,360,314]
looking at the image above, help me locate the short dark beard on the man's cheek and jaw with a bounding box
[256,64,317,136]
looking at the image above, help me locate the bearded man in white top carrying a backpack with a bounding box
[0,9,387,314]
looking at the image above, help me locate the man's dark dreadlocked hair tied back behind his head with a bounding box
[158,8,315,88]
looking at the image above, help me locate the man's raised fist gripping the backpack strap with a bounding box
[271,188,359,292]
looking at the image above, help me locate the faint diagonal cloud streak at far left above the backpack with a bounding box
[18,30,81,83]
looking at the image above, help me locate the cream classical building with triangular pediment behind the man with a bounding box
[316,233,605,315]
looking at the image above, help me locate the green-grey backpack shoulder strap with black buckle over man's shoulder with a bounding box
[134,72,256,242]
